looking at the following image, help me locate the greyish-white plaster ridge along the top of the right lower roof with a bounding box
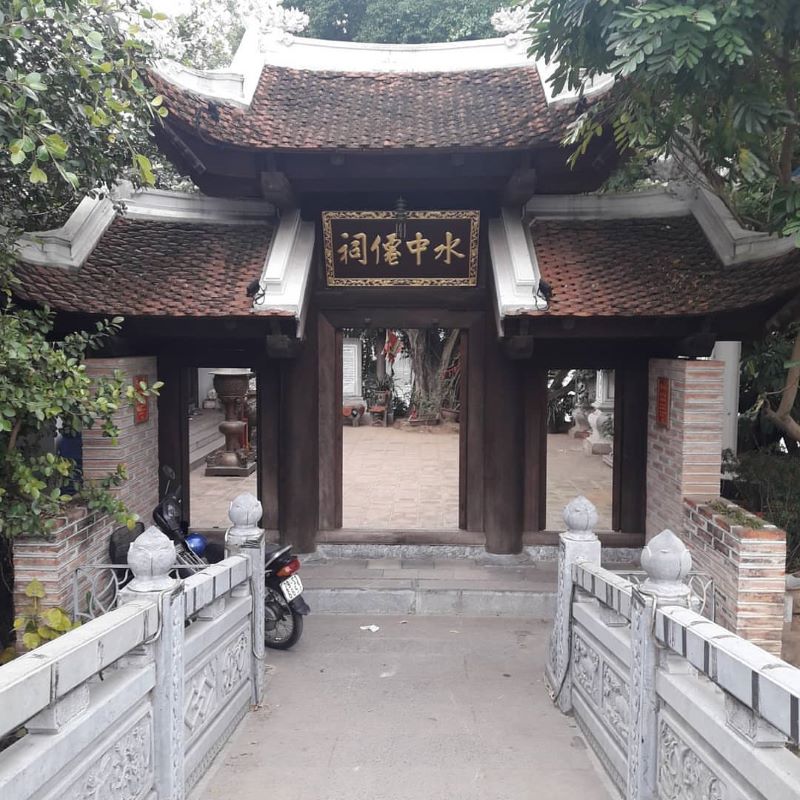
[525,185,795,266]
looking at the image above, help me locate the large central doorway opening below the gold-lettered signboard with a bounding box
[341,327,464,531]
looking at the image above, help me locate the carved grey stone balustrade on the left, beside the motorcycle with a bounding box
[0,495,264,800]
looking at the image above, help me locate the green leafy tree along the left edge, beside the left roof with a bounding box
[0,0,166,552]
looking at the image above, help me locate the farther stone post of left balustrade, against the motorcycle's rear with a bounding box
[225,492,264,704]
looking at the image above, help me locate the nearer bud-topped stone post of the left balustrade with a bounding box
[119,525,185,800]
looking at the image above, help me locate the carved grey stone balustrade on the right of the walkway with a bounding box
[545,498,800,800]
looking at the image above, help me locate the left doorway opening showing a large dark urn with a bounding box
[187,367,258,531]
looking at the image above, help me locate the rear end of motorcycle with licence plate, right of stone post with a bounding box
[264,544,311,650]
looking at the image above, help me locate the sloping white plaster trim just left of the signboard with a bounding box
[253,211,314,338]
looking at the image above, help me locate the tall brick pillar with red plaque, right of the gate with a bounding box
[646,359,724,539]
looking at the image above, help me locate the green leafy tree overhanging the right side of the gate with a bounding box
[529,0,800,441]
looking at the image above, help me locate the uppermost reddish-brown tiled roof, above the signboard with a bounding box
[151,66,574,150]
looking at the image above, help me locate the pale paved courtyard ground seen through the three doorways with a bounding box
[190,425,612,530]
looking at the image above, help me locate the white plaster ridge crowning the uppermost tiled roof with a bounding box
[156,28,614,108]
